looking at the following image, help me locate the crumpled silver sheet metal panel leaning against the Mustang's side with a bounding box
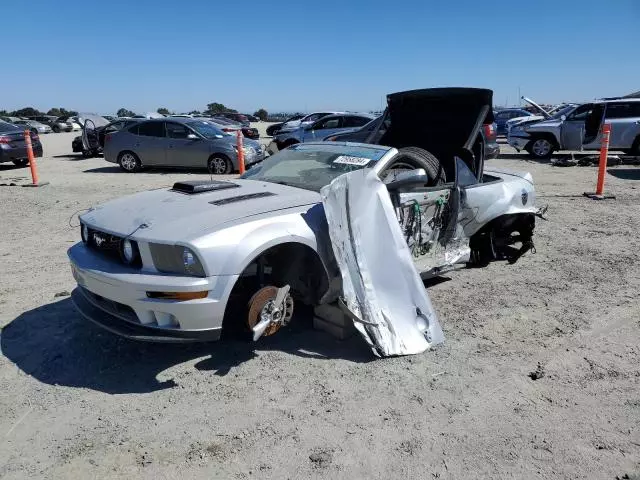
[320,169,444,356]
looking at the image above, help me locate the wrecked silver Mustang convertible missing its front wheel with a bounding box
[68,88,537,356]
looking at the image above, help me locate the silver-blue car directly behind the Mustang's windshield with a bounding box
[267,113,374,153]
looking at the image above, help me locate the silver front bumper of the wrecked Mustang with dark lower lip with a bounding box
[67,243,238,341]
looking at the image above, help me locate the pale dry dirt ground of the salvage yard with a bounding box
[0,127,640,480]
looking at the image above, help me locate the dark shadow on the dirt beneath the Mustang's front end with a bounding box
[0,298,375,393]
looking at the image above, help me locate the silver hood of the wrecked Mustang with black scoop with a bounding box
[80,180,320,243]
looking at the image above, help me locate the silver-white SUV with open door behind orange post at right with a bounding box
[507,98,640,158]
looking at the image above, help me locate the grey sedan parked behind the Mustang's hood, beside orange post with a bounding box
[104,118,264,174]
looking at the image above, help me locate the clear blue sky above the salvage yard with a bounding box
[0,0,640,113]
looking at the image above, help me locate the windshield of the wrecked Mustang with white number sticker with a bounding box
[241,144,388,192]
